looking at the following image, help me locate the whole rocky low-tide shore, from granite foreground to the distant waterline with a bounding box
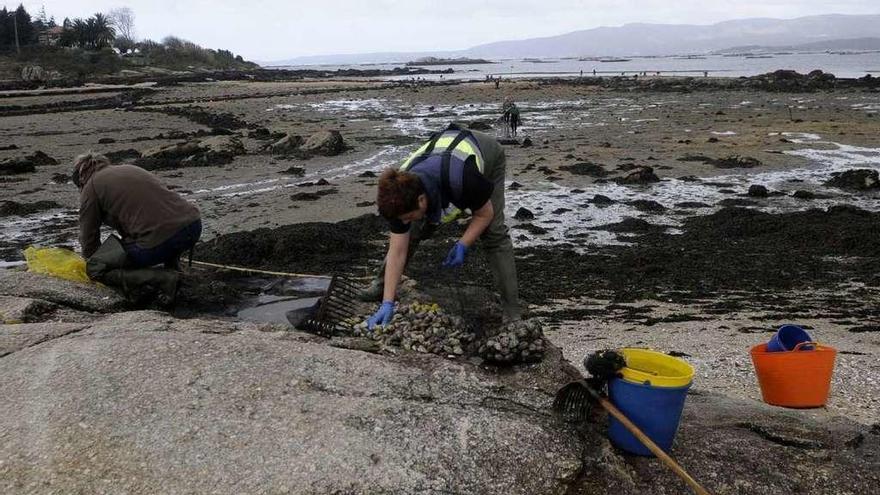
[0,74,880,494]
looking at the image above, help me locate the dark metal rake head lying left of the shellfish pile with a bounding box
[287,275,369,337]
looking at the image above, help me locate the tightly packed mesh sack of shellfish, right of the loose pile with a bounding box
[478,319,547,364]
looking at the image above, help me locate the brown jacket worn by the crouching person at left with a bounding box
[79,165,201,258]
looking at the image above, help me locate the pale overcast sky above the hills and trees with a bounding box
[6,0,880,61]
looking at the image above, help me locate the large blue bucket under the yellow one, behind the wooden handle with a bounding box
[608,378,691,456]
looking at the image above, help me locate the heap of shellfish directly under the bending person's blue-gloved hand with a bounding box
[353,303,475,356]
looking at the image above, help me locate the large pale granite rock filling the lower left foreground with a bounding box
[0,312,581,494]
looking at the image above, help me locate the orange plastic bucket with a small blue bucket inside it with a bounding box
[751,342,837,408]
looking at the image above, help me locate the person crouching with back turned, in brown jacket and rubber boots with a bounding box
[73,153,202,306]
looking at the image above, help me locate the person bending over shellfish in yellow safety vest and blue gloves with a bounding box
[362,124,521,329]
